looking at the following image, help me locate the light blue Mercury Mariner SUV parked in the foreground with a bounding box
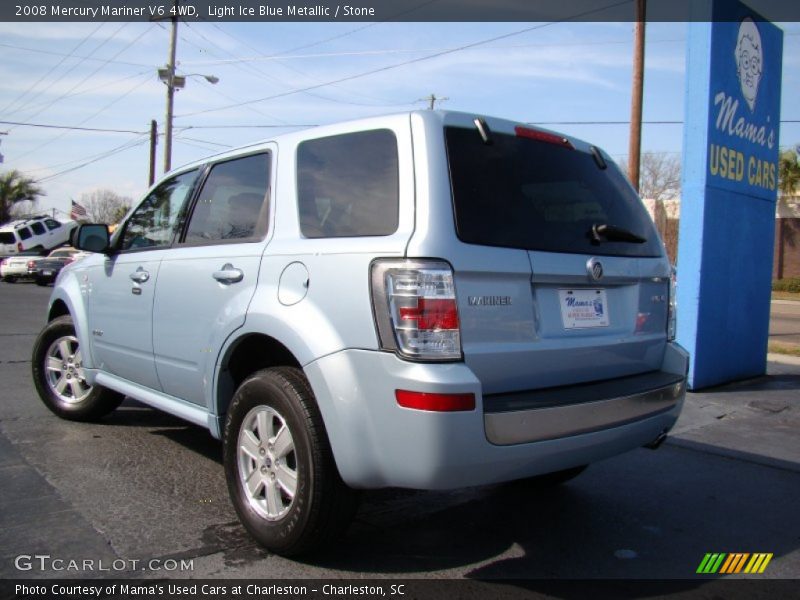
[33,111,687,555]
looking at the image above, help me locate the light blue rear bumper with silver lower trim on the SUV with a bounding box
[305,345,688,489]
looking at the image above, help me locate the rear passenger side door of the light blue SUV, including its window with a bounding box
[153,148,274,405]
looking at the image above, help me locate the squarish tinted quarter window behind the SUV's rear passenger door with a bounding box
[297,129,399,238]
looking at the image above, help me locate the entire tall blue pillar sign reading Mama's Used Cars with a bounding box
[677,0,783,389]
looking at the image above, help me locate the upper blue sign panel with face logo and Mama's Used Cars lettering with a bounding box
[708,2,783,199]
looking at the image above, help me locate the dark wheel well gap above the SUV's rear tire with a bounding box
[216,334,300,416]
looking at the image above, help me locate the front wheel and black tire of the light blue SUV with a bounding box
[31,315,125,421]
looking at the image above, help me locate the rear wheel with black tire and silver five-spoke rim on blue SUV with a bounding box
[223,367,358,556]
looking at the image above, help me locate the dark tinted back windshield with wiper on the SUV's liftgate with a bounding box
[445,127,661,257]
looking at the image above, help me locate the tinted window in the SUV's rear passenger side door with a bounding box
[184,154,270,244]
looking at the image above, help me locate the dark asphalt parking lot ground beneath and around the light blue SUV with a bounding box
[0,283,800,582]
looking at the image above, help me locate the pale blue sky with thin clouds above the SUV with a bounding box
[0,22,800,221]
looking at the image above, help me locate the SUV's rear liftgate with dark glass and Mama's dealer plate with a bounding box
[445,121,669,393]
